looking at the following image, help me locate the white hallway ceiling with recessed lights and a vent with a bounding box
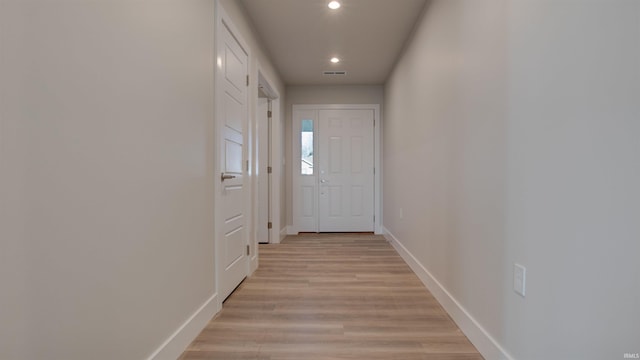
[240,0,425,85]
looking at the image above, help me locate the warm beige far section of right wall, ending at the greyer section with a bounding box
[383,0,506,358]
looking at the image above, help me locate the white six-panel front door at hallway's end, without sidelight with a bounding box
[318,110,374,232]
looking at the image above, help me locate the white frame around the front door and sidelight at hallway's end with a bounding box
[288,104,383,235]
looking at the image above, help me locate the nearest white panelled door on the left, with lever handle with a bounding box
[217,22,249,299]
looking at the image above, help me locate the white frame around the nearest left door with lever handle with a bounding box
[212,0,253,313]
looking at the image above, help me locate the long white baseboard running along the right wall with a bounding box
[382,227,513,360]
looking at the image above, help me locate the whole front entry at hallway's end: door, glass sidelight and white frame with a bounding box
[290,105,380,234]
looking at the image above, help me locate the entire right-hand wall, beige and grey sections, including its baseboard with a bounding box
[383,0,640,359]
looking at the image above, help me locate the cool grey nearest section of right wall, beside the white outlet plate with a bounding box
[505,0,640,359]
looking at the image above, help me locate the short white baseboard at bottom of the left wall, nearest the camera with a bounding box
[147,293,220,360]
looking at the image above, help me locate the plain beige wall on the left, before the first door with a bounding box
[0,0,215,360]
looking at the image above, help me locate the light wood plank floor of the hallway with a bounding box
[181,234,482,360]
